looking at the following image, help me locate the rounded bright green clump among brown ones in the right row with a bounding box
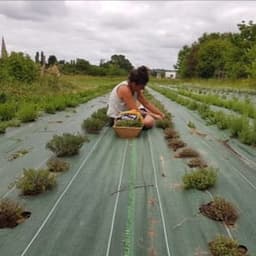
[182,167,217,190]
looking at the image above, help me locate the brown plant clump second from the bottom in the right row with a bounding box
[199,197,238,225]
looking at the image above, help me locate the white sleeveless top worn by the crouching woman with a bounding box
[107,81,137,118]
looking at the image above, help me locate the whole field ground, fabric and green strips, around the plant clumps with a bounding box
[0,77,256,256]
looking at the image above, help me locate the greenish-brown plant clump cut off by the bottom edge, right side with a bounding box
[208,235,247,256]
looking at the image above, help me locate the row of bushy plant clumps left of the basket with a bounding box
[0,103,112,228]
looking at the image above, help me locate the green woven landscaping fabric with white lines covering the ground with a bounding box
[0,91,256,256]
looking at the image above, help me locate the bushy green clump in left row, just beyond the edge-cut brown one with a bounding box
[16,169,57,195]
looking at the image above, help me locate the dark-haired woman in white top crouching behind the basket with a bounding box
[107,66,164,128]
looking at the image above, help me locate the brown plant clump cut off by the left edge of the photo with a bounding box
[0,198,30,228]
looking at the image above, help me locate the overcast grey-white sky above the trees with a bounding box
[0,0,256,69]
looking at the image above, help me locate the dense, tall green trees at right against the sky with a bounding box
[175,21,256,79]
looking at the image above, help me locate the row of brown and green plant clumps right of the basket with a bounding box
[149,91,247,256]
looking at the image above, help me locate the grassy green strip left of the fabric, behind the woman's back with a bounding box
[0,75,125,133]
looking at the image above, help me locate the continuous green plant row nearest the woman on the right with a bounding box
[150,87,256,145]
